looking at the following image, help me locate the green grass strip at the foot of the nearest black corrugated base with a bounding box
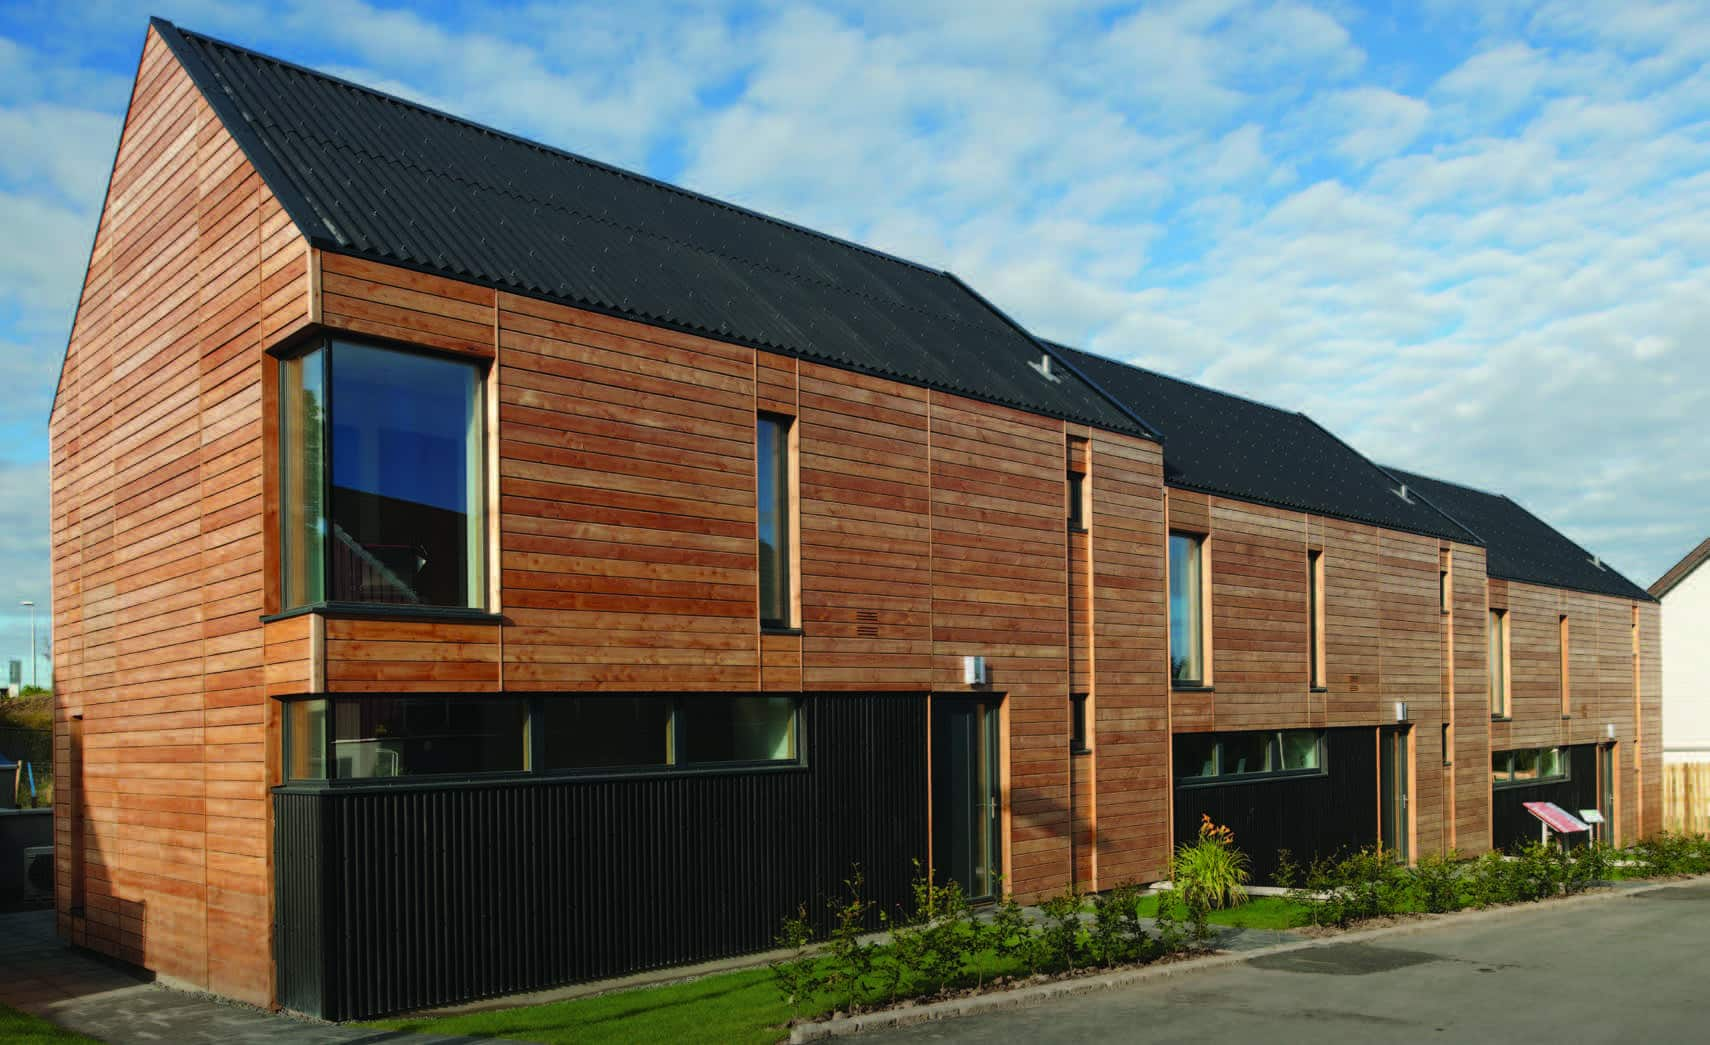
[362,968,820,1045]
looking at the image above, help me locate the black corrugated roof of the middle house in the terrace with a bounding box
[1057,345,1477,544]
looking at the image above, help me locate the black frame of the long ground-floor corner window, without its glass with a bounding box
[279,691,811,790]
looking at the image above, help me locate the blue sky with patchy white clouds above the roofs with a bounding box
[0,0,1710,677]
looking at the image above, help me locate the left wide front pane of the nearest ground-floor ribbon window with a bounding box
[332,694,528,780]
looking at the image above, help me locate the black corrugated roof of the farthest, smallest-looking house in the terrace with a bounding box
[1389,469,1650,602]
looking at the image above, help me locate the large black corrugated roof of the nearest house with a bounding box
[154,21,1156,438]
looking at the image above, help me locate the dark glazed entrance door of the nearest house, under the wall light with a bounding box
[932,696,1002,900]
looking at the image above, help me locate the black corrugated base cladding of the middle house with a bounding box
[1175,727,1378,884]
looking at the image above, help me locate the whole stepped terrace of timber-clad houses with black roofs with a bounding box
[51,21,1660,1018]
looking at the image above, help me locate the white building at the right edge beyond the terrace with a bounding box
[1650,539,1710,763]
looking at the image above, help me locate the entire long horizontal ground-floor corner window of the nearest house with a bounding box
[286,694,802,782]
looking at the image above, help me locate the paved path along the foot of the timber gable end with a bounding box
[0,910,495,1045]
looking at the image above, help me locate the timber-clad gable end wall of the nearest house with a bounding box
[50,29,308,1004]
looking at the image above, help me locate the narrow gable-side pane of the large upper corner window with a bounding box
[279,349,327,607]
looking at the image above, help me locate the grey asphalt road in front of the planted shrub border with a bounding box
[860,883,1710,1045]
